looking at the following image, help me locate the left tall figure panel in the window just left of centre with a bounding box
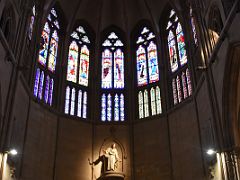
[67,41,78,83]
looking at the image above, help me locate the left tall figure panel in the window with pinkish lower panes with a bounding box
[168,31,178,72]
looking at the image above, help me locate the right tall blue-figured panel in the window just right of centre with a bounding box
[148,41,159,83]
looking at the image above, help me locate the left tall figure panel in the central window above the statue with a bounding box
[102,49,112,89]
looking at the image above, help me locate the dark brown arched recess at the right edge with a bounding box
[223,43,240,149]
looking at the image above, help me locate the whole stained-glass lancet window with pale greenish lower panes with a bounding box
[135,27,162,119]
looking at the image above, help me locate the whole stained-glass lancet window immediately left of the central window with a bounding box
[64,26,91,119]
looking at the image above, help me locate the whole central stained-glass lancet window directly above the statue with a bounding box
[101,32,125,122]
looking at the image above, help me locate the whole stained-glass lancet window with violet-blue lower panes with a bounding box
[34,8,60,106]
